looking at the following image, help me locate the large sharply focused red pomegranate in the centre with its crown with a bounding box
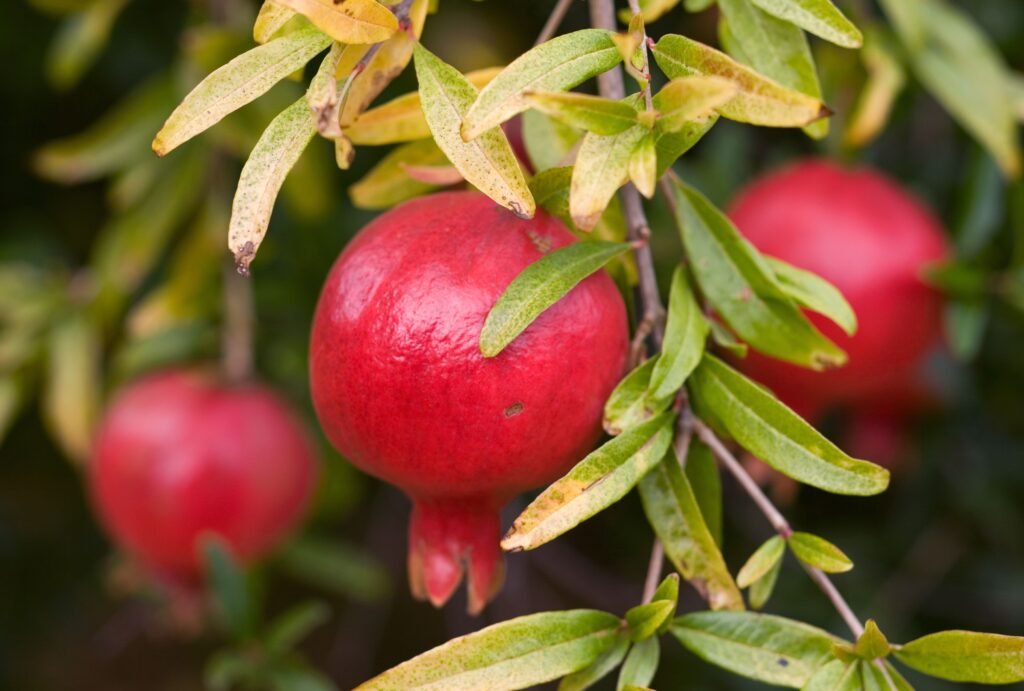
[310,191,628,613]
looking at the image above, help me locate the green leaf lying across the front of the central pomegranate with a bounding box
[480,240,630,357]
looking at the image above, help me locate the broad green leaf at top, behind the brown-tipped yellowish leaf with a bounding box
[719,0,829,139]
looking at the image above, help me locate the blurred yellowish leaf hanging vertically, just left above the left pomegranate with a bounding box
[42,312,102,463]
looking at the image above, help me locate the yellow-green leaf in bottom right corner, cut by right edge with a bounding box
[896,631,1024,684]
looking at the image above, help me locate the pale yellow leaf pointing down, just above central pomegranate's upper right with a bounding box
[569,125,648,230]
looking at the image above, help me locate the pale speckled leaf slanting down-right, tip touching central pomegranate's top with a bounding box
[415,44,536,218]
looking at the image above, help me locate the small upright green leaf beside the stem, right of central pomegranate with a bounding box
[650,266,709,399]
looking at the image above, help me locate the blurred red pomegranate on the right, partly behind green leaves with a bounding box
[729,161,948,427]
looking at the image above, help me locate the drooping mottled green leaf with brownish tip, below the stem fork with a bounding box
[640,454,743,609]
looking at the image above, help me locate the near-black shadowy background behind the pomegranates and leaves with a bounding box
[0,0,1024,691]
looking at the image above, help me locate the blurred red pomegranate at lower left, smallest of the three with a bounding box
[89,370,316,582]
